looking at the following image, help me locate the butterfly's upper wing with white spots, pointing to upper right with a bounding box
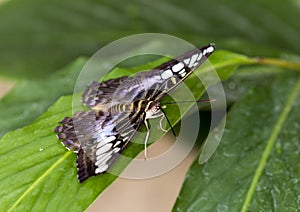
[82,44,214,110]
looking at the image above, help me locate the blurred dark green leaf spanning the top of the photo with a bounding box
[0,0,300,78]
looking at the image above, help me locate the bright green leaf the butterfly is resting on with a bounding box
[0,51,241,211]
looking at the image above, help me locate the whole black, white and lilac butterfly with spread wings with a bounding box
[54,44,215,182]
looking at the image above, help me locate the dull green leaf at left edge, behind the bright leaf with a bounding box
[0,58,86,137]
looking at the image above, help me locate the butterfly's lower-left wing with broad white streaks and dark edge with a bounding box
[55,110,145,182]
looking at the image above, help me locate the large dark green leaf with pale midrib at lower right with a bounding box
[173,70,300,211]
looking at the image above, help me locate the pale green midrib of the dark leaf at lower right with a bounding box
[241,77,300,212]
